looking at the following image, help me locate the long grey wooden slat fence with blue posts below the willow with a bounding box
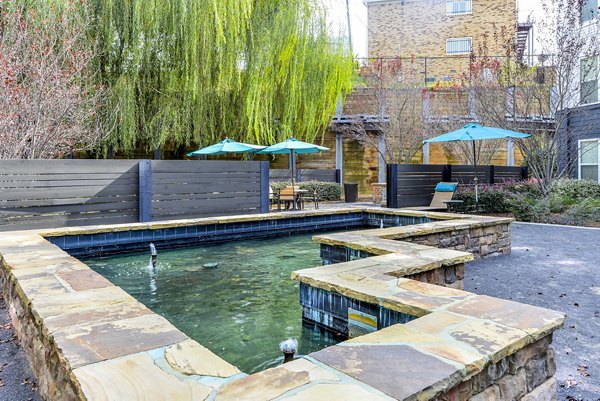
[0,160,269,231]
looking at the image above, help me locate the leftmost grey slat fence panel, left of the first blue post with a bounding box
[0,160,138,231]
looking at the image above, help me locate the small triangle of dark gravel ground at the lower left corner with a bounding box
[0,296,41,401]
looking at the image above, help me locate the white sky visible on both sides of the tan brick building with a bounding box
[321,0,543,57]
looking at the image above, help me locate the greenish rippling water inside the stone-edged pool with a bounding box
[85,234,342,373]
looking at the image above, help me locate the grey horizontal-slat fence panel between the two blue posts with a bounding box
[152,160,262,220]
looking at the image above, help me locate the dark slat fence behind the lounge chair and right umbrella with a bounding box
[387,164,528,208]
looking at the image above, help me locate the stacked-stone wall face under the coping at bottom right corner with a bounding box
[436,335,556,401]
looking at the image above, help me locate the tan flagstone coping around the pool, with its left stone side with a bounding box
[0,208,564,400]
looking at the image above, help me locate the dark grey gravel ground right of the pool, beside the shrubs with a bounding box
[465,223,600,401]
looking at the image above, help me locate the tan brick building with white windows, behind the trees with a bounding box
[363,0,526,82]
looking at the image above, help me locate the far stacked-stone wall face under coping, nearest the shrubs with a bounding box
[401,220,511,258]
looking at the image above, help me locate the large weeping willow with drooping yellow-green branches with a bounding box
[91,0,353,151]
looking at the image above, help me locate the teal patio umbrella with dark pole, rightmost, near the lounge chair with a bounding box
[425,123,531,202]
